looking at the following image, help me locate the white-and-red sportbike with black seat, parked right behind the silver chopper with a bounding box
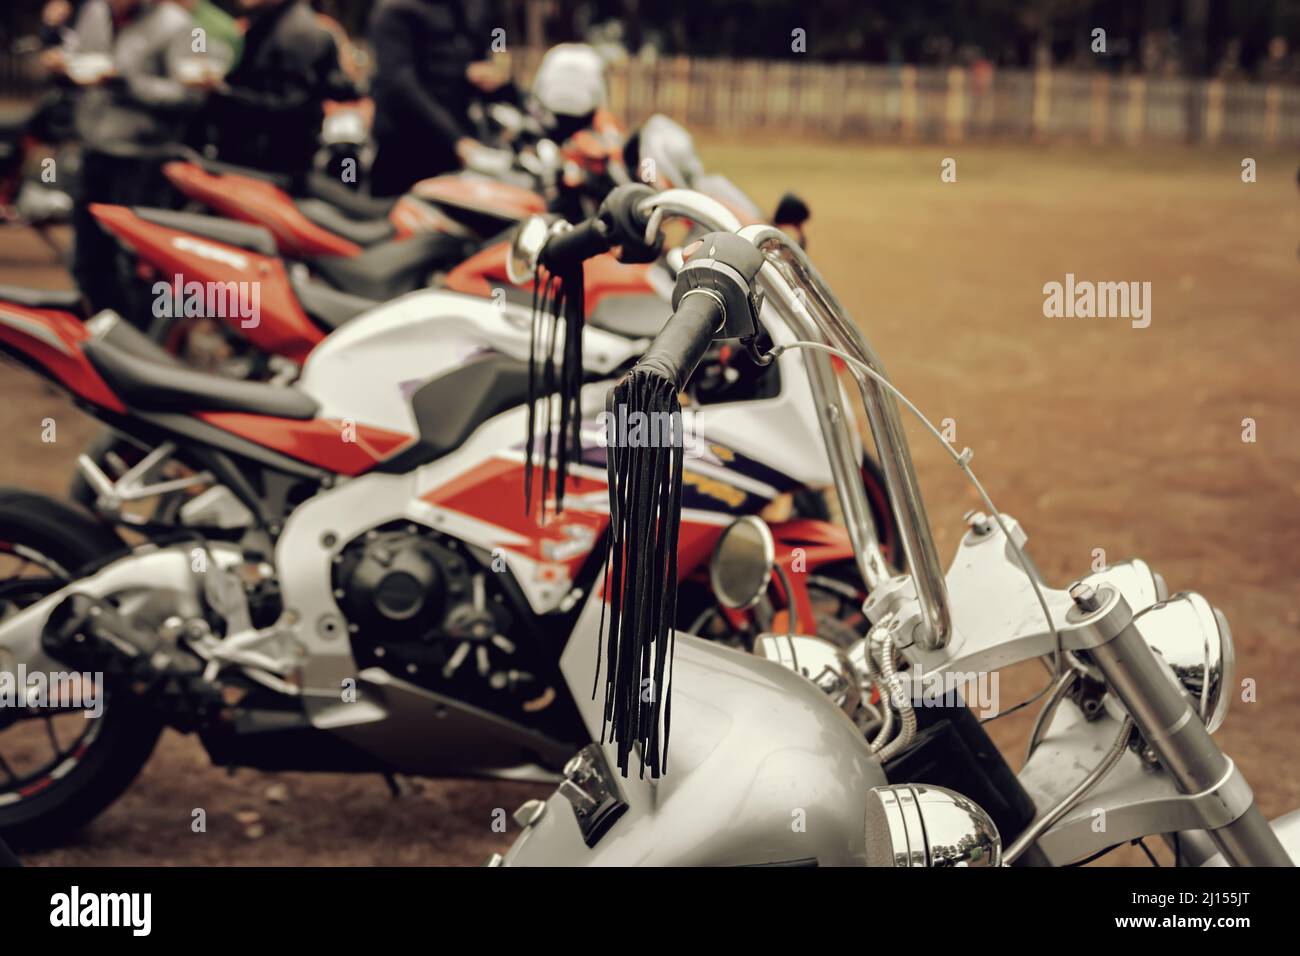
[0,187,884,843]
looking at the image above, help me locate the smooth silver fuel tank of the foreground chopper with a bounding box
[503,635,885,866]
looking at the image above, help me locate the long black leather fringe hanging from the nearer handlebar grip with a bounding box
[592,367,684,777]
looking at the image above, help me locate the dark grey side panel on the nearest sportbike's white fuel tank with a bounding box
[377,352,528,473]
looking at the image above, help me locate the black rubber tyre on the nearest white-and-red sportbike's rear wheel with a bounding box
[0,489,163,848]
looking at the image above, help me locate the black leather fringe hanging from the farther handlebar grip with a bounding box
[524,265,585,522]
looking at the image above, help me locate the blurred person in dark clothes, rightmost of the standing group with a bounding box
[371,0,507,196]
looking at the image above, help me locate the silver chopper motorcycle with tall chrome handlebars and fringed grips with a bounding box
[489,184,1300,866]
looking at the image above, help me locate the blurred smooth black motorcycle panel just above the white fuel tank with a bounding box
[308,233,469,302]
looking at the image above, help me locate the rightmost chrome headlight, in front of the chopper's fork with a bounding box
[1134,591,1236,734]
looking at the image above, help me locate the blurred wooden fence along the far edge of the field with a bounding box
[0,49,1300,147]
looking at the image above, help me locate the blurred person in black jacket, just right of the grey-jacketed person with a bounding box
[208,0,358,183]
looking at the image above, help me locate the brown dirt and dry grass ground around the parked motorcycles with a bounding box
[0,138,1300,865]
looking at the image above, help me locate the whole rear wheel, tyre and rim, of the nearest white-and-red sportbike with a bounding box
[0,490,163,848]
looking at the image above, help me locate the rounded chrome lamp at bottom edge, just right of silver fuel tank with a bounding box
[867,783,1002,868]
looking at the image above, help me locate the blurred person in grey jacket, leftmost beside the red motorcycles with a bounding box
[73,0,206,319]
